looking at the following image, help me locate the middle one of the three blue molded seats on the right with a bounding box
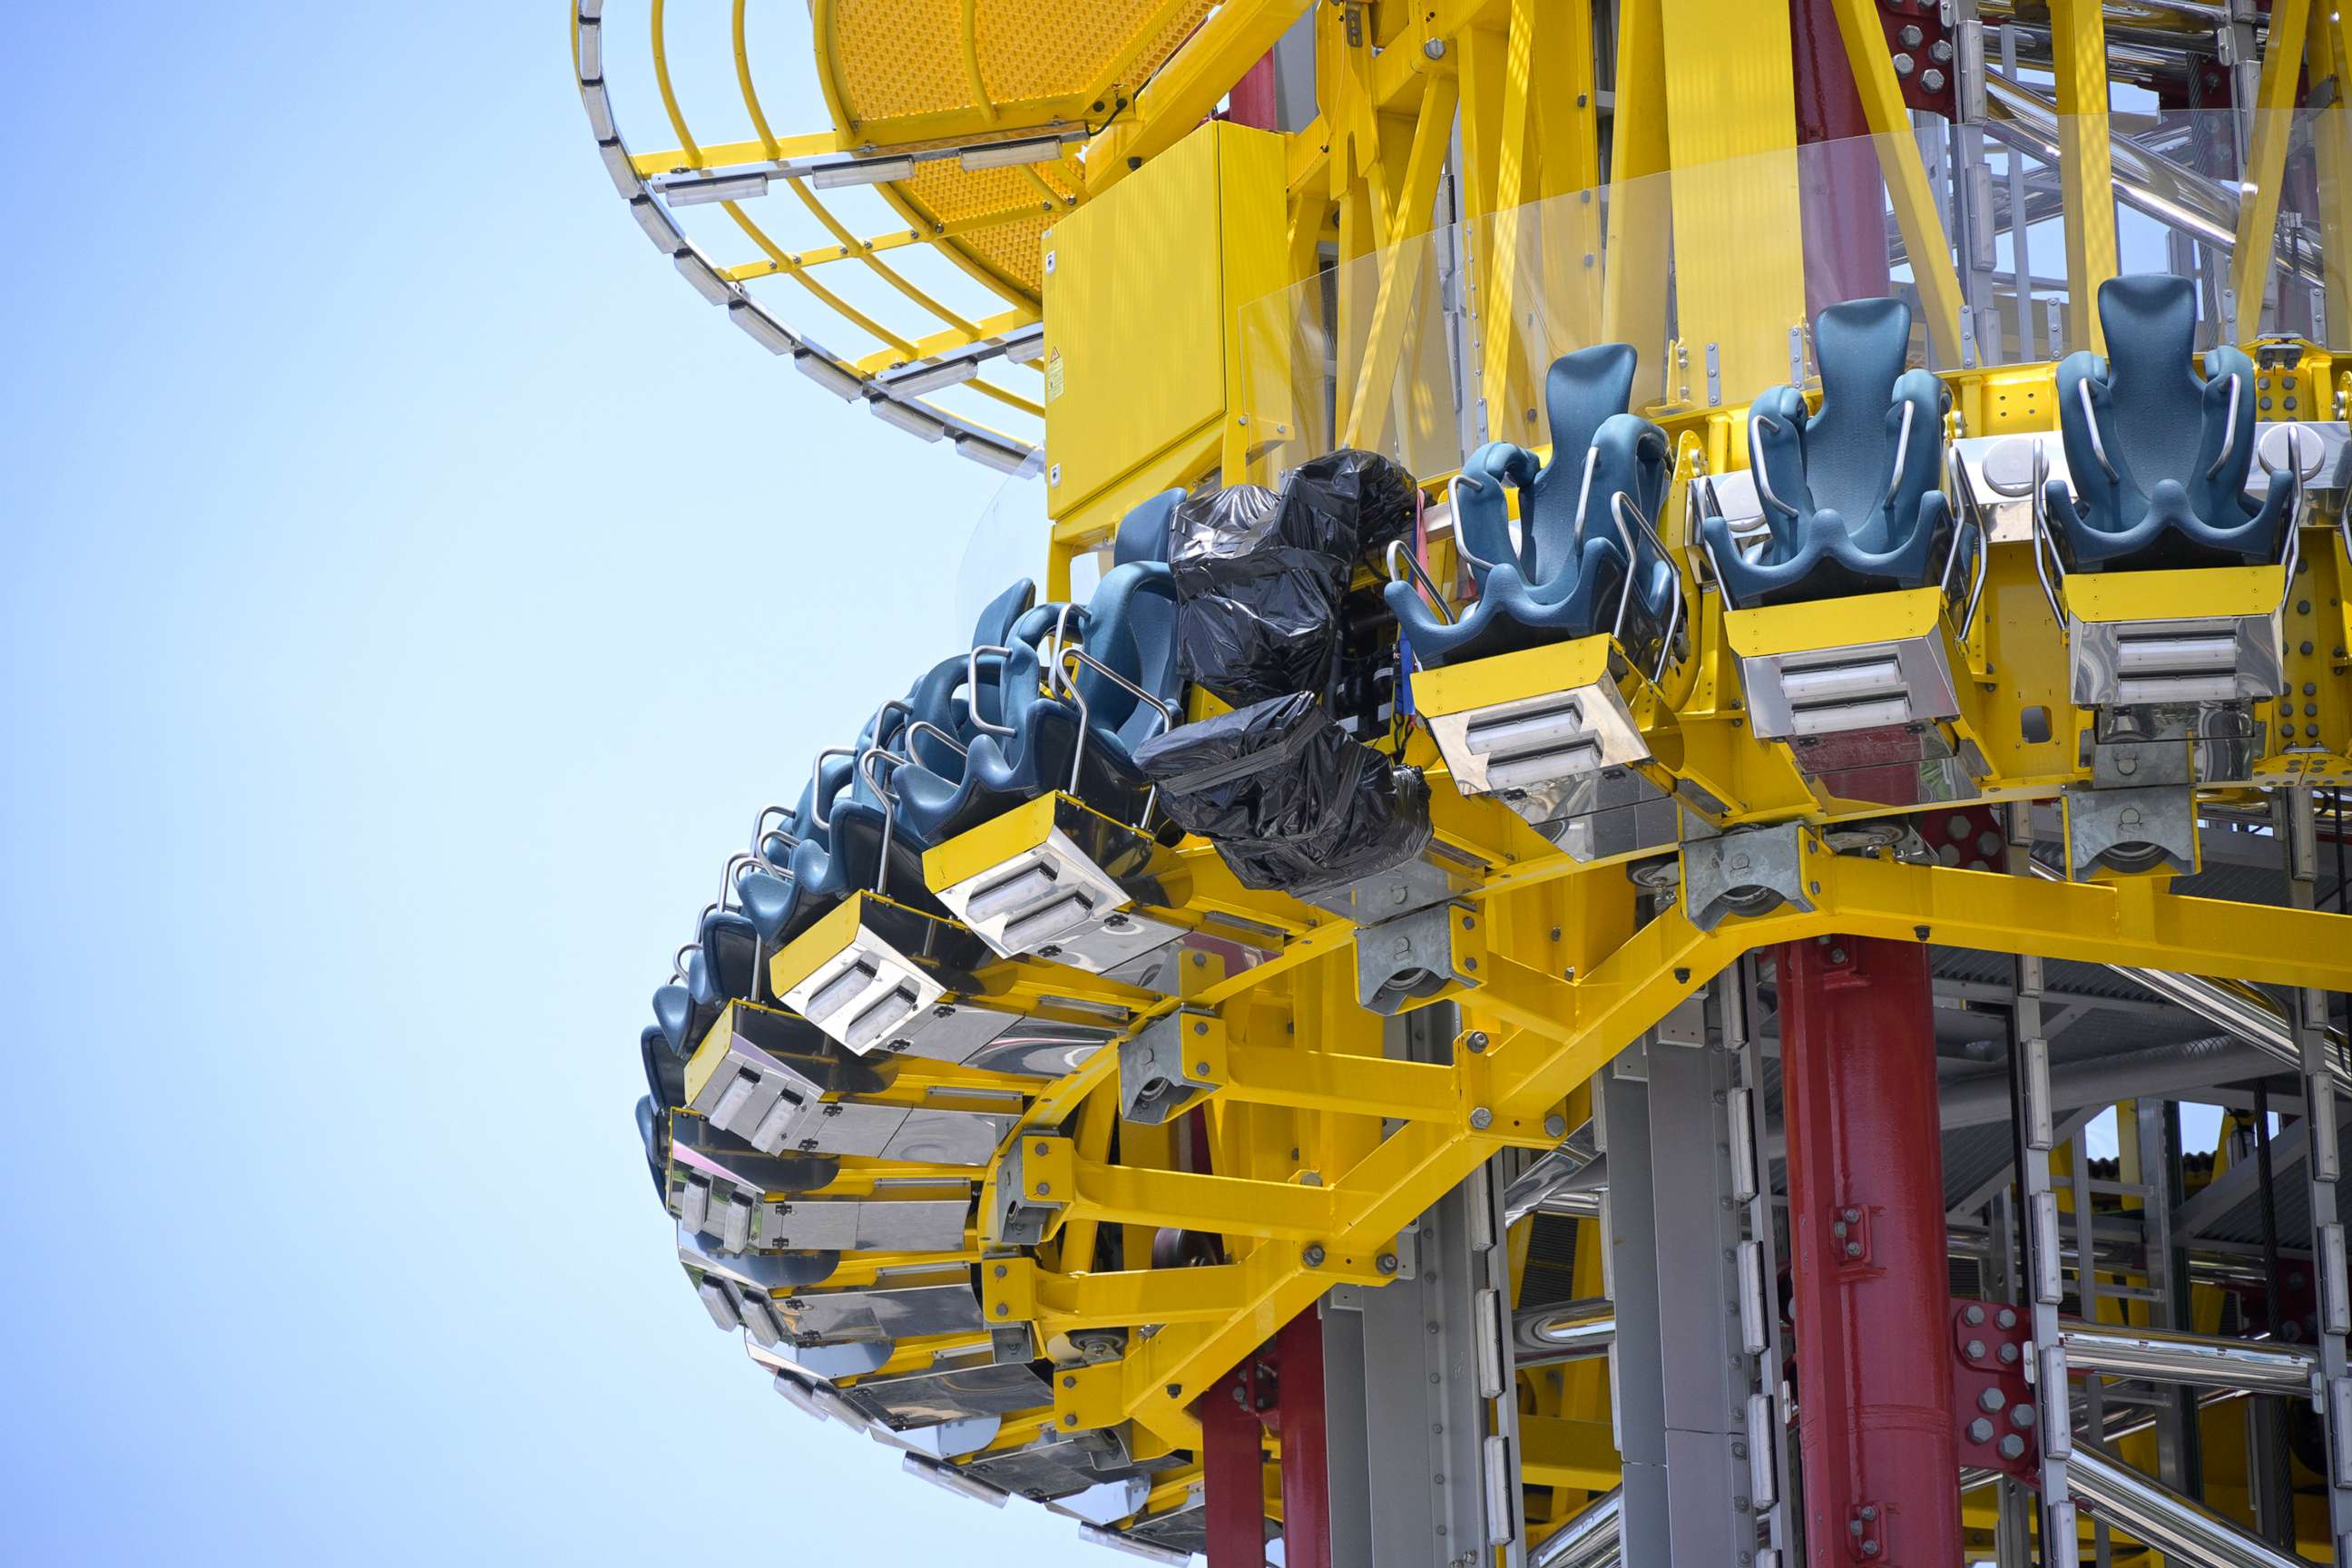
[1700,299,1952,609]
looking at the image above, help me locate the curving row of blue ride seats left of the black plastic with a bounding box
[637,491,1183,1175]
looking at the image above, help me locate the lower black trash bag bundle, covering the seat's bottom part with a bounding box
[1136,691,1430,896]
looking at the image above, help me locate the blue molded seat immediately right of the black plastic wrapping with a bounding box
[1386,343,1681,665]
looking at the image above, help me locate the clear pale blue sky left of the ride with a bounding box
[0,12,1091,1565]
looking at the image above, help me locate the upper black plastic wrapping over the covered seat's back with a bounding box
[1169,449,1414,705]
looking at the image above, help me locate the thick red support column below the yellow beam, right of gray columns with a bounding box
[1776,936,1962,1568]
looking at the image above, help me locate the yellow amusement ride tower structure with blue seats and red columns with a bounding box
[572,0,2352,1568]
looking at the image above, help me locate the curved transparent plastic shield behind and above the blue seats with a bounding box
[1242,108,2352,477]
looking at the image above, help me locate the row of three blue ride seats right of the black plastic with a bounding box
[1387,275,2291,665]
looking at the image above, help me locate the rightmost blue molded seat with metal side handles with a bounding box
[2043,273,2296,572]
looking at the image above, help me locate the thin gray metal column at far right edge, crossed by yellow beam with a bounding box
[2279,789,2352,1563]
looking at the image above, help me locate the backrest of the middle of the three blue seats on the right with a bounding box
[1790,299,1938,540]
